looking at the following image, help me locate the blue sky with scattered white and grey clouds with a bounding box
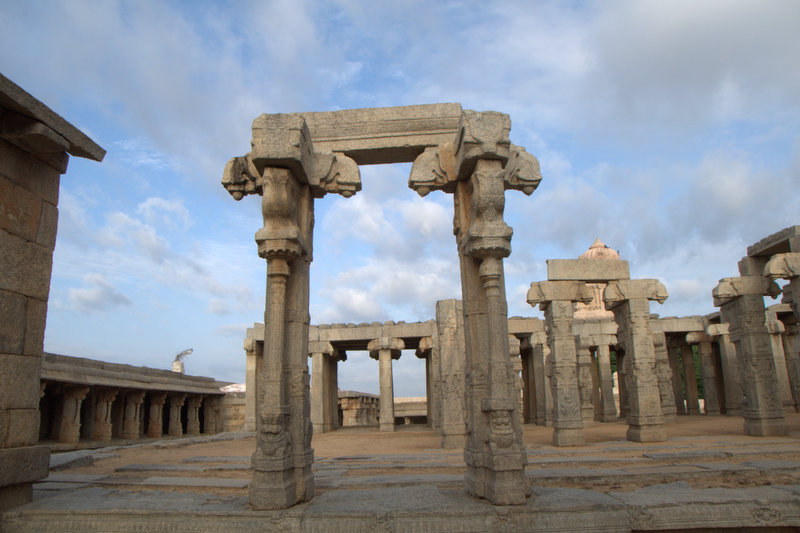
[0,0,800,396]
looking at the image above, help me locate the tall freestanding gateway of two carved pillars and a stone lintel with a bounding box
[223,104,541,509]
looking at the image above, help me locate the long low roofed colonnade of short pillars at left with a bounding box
[38,354,223,449]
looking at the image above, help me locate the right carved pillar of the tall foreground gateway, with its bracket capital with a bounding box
[409,110,541,505]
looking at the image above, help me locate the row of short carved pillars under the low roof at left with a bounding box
[40,381,222,444]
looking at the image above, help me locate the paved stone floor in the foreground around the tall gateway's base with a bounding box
[0,424,800,533]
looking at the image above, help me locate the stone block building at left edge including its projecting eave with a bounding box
[0,75,105,511]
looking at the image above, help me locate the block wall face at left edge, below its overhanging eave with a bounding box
[0,139,60,510]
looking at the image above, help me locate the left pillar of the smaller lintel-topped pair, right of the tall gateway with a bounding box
[528,281,594,446]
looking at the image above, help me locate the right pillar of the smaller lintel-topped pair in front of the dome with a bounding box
[603,279,667,442]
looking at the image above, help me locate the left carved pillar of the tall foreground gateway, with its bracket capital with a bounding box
[222,114,361,509]
